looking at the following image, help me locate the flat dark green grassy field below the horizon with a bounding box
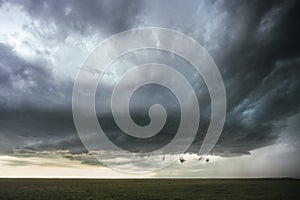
[0,179,300,200]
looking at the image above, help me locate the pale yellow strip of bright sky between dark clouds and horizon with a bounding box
[0,144,300,178]
